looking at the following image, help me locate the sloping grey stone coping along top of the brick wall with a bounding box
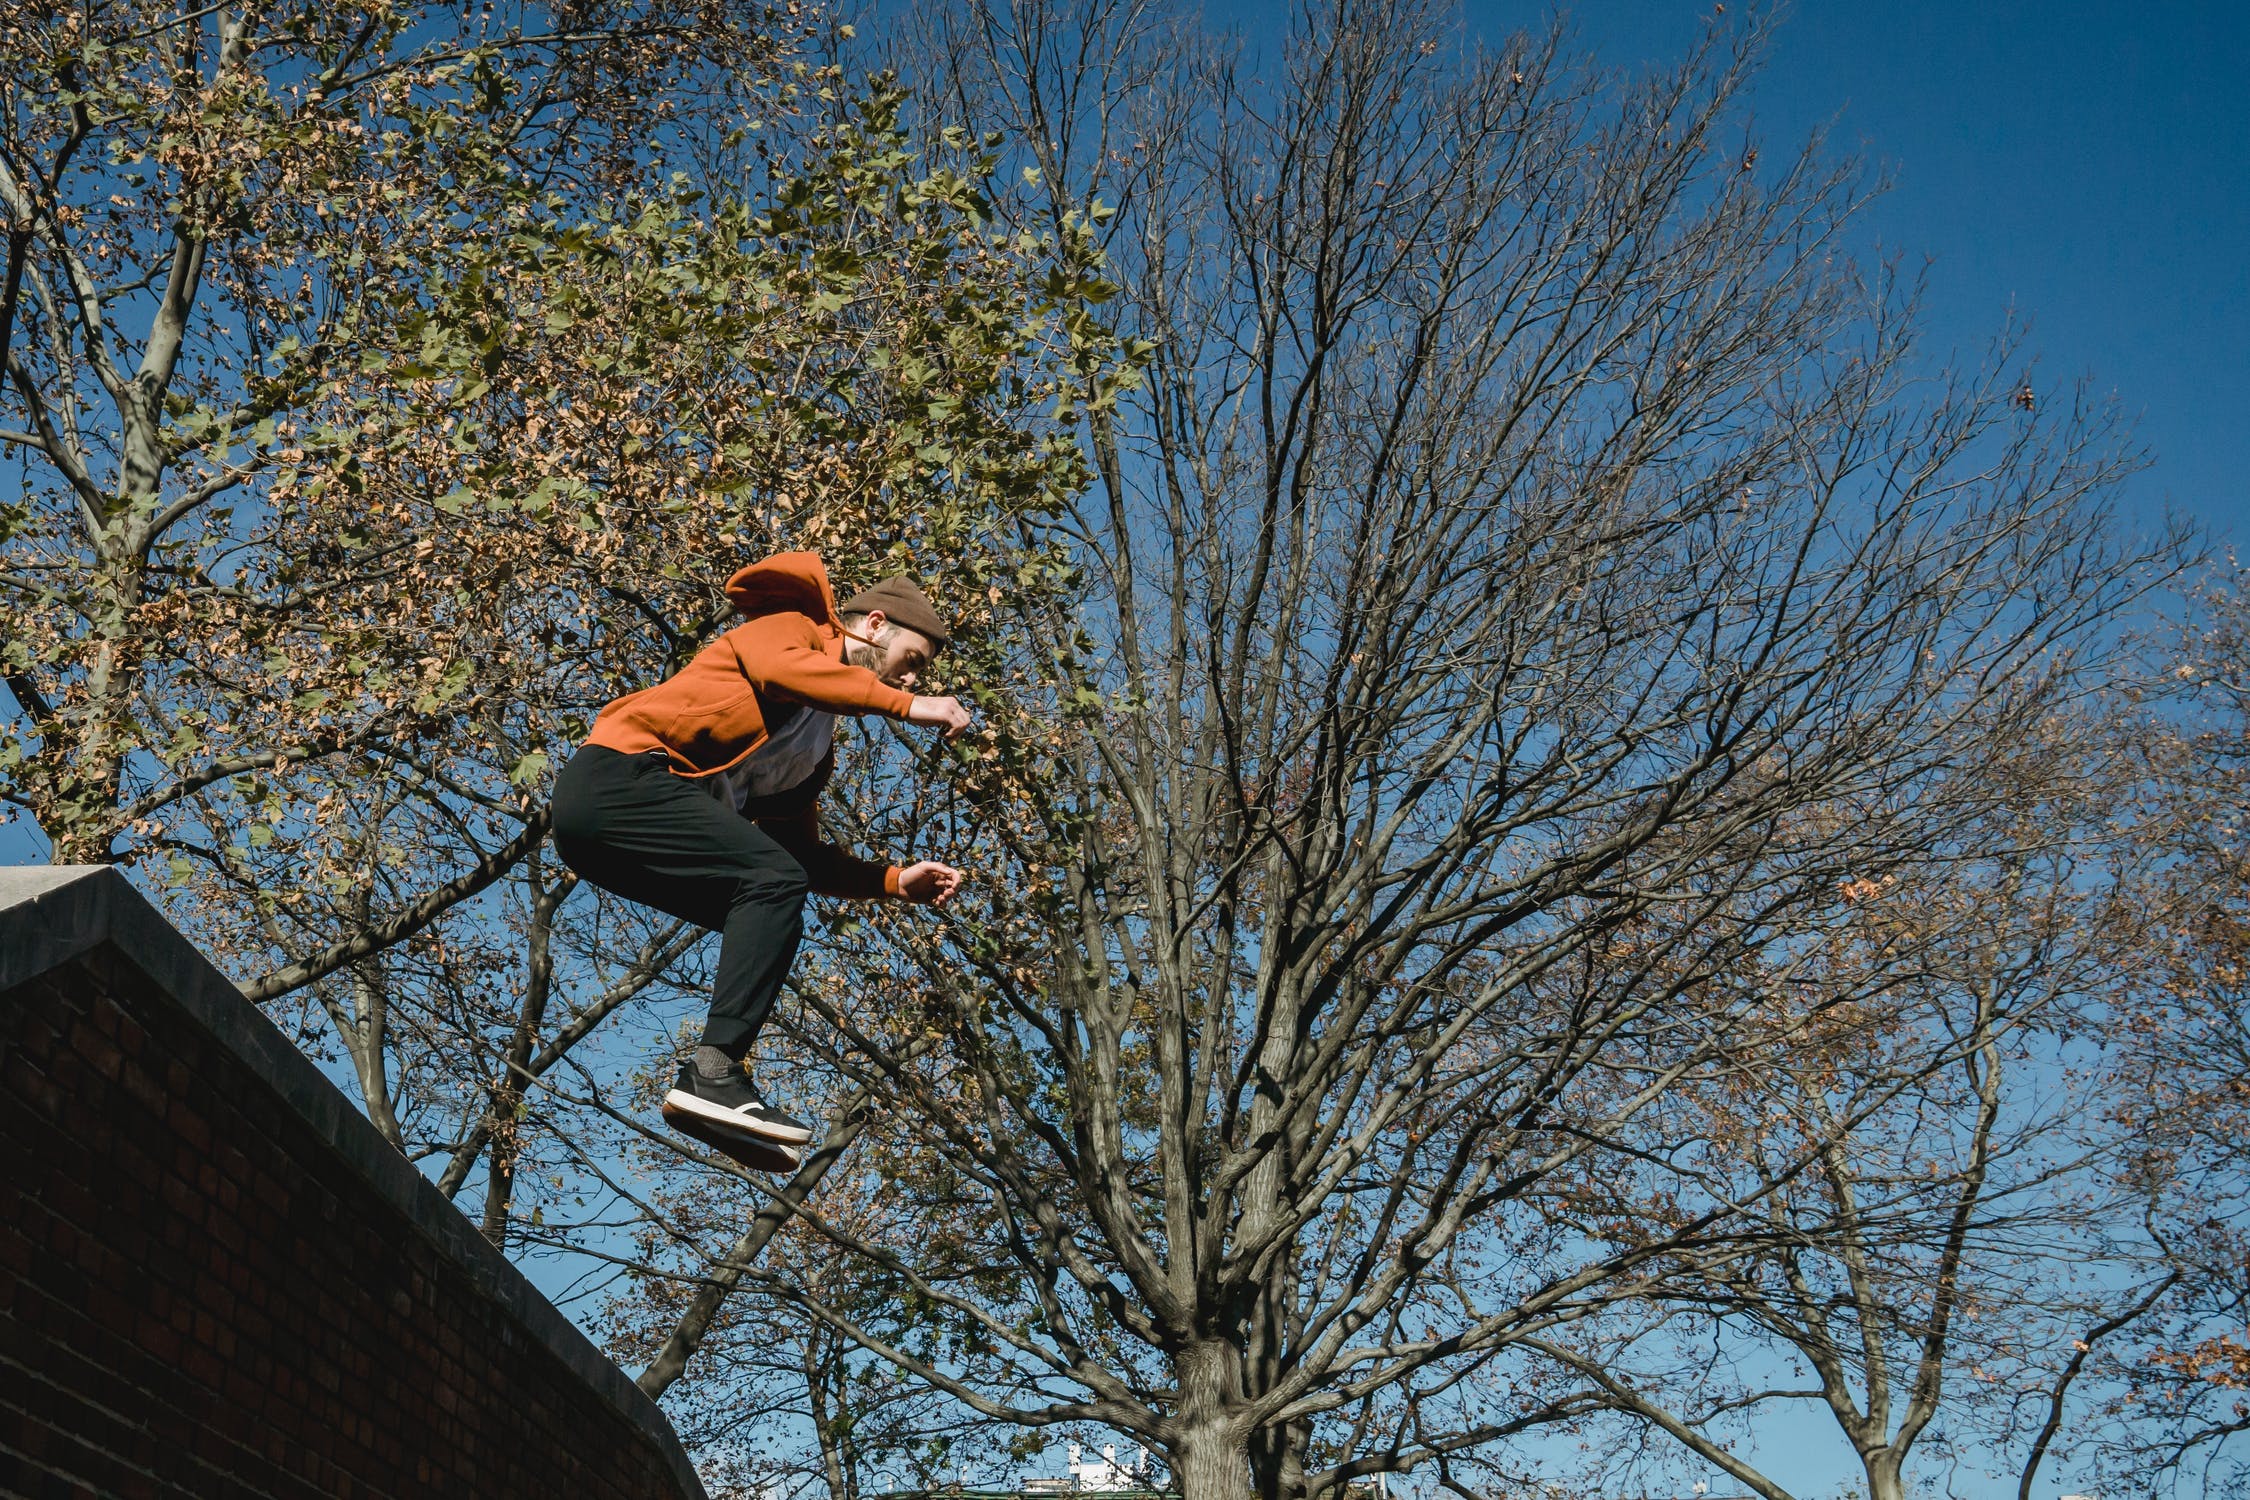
[0,864,704,1500]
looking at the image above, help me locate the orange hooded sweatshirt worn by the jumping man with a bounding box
[585,551,914,897]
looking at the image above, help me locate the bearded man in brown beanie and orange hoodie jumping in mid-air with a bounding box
[554,553,970,1167]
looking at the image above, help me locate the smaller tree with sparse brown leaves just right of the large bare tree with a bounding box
[1537,805,2176,1500]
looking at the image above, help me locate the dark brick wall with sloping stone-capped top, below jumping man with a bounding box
[0,870,702,1500]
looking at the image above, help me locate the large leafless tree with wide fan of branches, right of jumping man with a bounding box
[607,0,2171,1500]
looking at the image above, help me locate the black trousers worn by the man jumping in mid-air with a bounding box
[554,744,806,1052]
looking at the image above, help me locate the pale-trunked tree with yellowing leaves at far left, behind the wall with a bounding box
[0,0,790,861]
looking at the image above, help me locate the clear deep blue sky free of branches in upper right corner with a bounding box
[1566,0,2250,555]
